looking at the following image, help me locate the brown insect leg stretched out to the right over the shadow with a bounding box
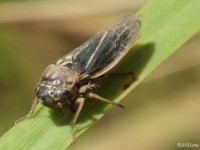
[86,92,124,109]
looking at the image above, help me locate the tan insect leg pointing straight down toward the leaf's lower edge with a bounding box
[71,98,85,143]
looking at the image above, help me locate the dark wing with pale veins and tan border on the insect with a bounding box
[72,17,140,79]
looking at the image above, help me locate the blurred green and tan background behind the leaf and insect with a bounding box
[0,0,200,150]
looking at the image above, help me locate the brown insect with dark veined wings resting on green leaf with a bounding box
[17,16,140,140]
